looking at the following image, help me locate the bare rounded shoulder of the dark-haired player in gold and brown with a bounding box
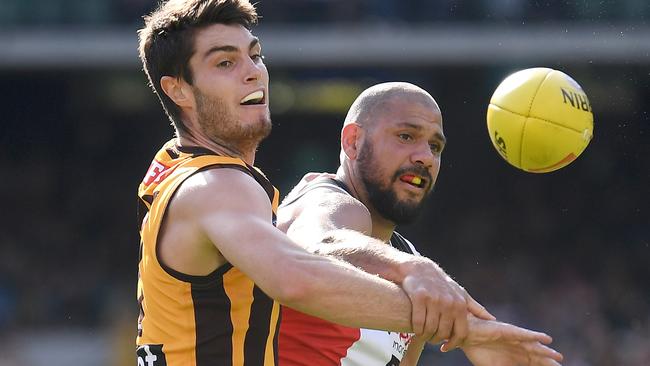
[159,168,272,275]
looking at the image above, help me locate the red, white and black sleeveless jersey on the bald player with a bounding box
[279,178,418,366]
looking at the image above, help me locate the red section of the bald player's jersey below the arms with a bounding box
[278,306,361,366]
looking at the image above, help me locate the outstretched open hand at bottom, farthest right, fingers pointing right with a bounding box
[440,317,563,366]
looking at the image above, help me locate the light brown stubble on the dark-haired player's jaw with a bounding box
[194,89,272,152]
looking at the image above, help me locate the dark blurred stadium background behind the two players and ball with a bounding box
[0,0,650,366]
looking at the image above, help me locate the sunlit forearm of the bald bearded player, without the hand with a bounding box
[309,229,435,285]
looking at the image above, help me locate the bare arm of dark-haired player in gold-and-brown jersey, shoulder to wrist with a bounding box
[174,169,412,331]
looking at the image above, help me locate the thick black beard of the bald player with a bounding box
[357,142,433,225]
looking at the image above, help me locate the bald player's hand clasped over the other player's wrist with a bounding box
[401,258,494,346]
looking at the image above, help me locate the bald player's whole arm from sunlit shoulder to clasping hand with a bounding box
[278,188,494,344]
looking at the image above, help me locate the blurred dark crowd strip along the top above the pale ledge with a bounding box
[0,0,650,27]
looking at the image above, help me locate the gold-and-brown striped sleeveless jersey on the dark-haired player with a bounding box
[136,140,280,366]
